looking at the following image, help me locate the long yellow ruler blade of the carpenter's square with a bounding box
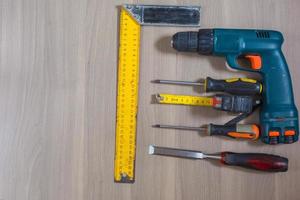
[114,8,141,182]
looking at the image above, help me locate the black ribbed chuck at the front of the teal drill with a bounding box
[171,29,214,55]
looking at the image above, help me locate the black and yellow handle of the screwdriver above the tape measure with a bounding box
[205,77,262,95]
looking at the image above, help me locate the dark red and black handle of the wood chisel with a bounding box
[221,152,288,172]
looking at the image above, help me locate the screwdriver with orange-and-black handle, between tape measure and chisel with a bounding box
[153,124,259,140]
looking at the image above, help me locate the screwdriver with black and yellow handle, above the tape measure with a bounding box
[152,77,262,95]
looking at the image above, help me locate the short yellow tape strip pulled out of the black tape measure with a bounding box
[156,94,213,106]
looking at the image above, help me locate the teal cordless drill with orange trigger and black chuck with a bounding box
[172,29,299,144]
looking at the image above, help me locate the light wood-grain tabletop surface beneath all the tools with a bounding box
[0,0,300,200]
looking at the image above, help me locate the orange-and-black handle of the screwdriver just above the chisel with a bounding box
[208,124,259,140]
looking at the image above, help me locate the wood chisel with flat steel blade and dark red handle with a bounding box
[149,145,288,172]
